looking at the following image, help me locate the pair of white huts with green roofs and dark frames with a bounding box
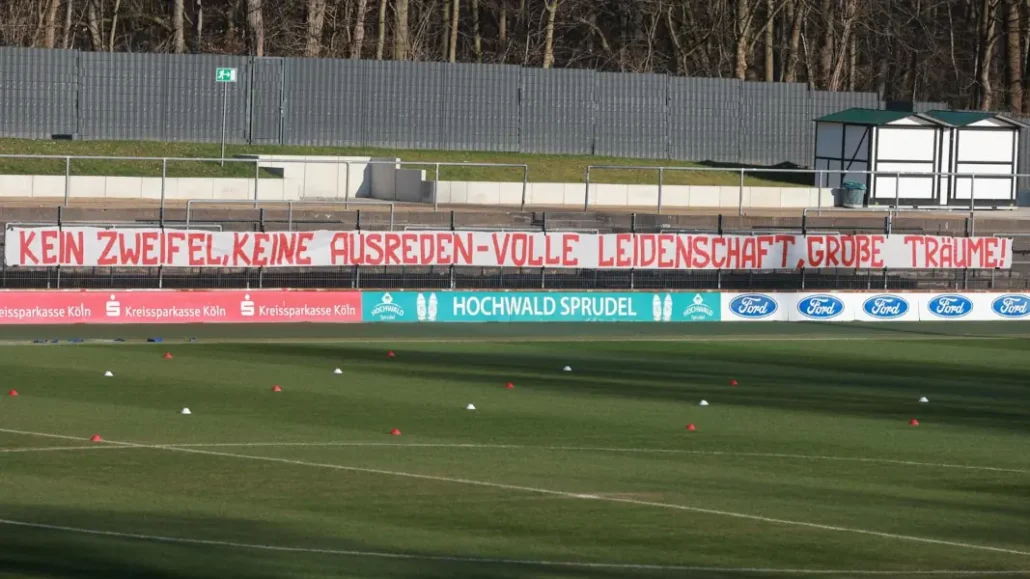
[814,108,1023,207]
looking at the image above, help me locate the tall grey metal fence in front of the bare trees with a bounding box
[0,47,947,166]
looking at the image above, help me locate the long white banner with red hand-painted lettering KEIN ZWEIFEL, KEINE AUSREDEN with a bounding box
[4,227,1012,270]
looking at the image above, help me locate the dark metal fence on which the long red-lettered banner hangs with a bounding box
[0,207,1030,291]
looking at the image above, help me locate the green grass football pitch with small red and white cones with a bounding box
[0,322,1030,579]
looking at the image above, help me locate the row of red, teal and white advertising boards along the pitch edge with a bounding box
[0,290,1030,326]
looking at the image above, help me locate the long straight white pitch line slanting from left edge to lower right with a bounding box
[0,429,1030,557]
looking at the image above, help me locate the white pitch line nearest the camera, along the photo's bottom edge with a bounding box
[0,518,1030,576]
